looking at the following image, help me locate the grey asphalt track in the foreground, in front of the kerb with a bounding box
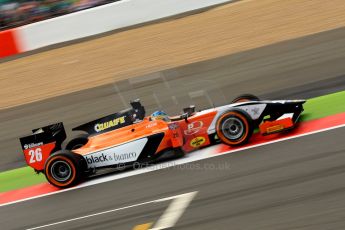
[0,128,345,230]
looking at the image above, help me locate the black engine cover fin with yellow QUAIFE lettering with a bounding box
[72,99,145,135]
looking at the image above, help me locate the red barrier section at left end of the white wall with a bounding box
[0,29,20,58]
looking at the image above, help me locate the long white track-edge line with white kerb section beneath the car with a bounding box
[0,124,345,207]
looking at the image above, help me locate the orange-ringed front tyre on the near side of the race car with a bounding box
[216,109,254,146]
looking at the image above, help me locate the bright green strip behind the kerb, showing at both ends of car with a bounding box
[0,91,345,193]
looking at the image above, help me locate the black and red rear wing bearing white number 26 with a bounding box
[19,122,66,171]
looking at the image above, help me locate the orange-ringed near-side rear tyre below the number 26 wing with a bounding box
[44,151,86,188]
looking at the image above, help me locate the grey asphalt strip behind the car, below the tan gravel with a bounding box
[0,28,345,171]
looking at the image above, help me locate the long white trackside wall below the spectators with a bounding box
[18,0,232,51]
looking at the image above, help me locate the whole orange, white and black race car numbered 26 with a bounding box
[20,94,305,188]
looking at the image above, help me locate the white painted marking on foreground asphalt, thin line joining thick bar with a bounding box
[26,191,198,230]
